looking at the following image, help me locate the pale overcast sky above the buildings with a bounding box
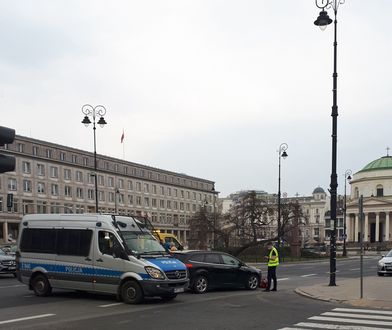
[0,0,392,197]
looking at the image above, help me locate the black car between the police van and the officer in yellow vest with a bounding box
[173,251,261,293]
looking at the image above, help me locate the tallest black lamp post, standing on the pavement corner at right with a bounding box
[314,0,345,286]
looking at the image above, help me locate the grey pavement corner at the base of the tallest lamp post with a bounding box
[295,276,392,310]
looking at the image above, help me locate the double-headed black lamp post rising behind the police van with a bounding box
[82,104,107,213]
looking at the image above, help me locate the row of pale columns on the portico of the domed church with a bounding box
[346,212,392,242]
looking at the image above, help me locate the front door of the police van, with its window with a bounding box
[94,229,125,294]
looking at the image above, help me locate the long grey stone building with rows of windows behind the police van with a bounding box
[0,136,216,244]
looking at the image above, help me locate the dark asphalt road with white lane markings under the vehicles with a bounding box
[0,257,377,330]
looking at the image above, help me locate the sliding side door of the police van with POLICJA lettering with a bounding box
[51,228,94,291]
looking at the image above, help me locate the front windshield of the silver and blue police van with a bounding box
[121,231,165,254]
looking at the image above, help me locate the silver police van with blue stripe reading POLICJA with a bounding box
[16,214,189,304]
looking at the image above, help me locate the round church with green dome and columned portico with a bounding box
[346,155,392,246]
